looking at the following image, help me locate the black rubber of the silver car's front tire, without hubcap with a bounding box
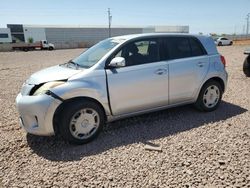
[59,100,104,144]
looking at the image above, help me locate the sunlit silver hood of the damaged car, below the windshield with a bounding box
[26,65,82,85]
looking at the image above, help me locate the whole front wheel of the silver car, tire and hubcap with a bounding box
[59,100,104,144]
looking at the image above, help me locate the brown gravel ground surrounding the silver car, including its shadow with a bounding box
[0,46,250,187]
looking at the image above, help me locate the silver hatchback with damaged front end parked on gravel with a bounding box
[16,34,227,144]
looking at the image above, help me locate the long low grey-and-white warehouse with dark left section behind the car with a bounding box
[4,24,189,48]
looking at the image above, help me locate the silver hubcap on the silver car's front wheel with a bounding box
[70,108,100,139]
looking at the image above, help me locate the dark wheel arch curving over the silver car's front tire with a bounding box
[53,96,107,135]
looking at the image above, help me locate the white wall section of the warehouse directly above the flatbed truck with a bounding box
[23,26,46,42]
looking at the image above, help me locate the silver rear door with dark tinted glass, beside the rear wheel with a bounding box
[165,36,209,104]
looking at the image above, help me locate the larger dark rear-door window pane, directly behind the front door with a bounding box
[165,37,192,59]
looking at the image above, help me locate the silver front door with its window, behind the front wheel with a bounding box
[106,39,168,115]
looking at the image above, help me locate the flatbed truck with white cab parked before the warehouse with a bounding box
[12,40,55,51]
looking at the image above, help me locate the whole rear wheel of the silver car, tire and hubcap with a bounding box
[195,80,222,112]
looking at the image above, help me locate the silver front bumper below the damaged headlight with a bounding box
[16,93,61,136]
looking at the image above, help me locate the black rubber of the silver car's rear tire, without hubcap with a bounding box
[195,80,223,112]
